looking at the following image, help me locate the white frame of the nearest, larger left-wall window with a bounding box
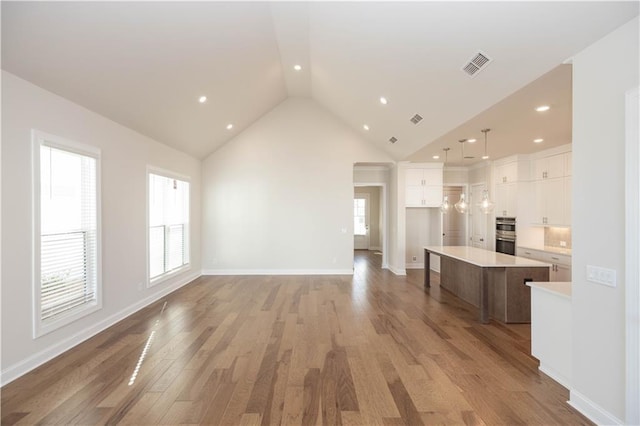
[31,129,102,339]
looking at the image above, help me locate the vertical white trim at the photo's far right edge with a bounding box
[625,87,640,424]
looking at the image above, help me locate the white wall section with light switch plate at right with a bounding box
[571,18,639,423]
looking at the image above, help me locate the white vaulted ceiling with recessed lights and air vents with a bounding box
[2,1,638,160]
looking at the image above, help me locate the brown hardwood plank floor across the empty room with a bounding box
[2,251,591,425]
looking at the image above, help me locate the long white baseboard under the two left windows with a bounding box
[0,273,200,386]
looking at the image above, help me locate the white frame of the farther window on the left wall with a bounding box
[145,165,192,288]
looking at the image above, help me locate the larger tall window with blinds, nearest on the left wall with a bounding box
[33,131,102,337]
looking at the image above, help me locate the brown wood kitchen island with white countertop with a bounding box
[424,246,551,323]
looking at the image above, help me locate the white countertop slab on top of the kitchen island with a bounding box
[424,246,551,268]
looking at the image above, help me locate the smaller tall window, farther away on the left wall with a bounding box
[149,173,189,285]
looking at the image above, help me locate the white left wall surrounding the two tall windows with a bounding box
[2,72,201,383]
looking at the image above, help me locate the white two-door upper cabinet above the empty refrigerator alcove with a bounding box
[404,163,443,207]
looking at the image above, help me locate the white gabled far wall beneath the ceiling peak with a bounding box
[202,98,393,274]
